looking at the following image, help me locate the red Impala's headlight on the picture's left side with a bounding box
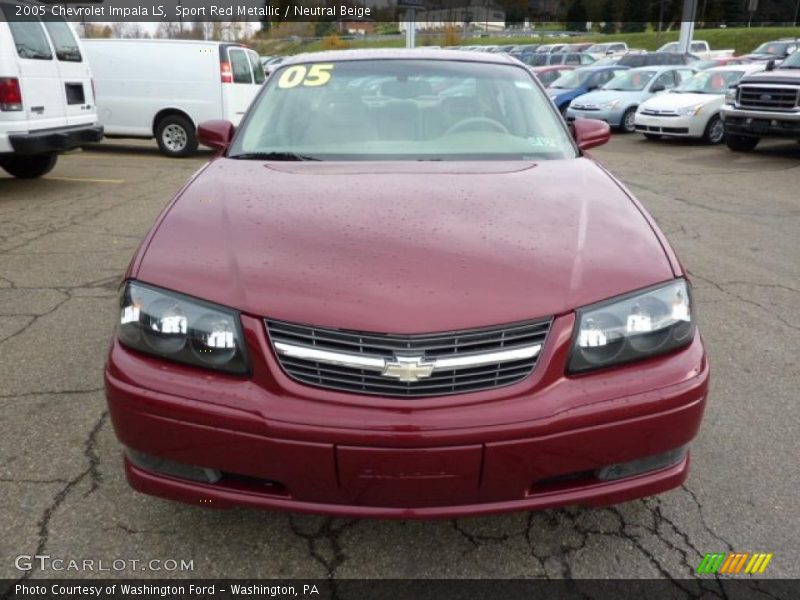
[117,281,248,375]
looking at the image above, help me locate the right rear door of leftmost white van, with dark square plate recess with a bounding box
[44,20,97,125]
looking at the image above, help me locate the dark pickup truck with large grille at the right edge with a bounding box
[721,50,800,152]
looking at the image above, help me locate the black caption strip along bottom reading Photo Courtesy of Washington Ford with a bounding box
[0,577,800,600]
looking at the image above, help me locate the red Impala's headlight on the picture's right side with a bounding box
[569,279,695,373]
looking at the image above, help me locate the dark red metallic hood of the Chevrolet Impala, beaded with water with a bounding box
[138,158,674,333]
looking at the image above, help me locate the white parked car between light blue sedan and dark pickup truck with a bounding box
[635,64,764,144]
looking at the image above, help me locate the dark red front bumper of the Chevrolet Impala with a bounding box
[105,317,708,518]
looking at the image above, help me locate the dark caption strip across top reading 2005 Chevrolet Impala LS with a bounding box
[0,0,800,23]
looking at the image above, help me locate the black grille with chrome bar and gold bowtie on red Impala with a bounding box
[266,319,552,397]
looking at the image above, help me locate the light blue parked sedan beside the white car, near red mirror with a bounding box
[566,66,694,133]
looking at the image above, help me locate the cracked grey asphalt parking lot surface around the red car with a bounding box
[0,135,800,584]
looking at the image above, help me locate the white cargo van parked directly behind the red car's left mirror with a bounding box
[84,39,265,156]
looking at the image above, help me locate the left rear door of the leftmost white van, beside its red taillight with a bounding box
[0,3,66,129]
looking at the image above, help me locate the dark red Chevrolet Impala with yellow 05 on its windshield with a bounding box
[105,50,708,518]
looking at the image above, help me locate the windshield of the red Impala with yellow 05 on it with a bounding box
[228,59,576,161]
